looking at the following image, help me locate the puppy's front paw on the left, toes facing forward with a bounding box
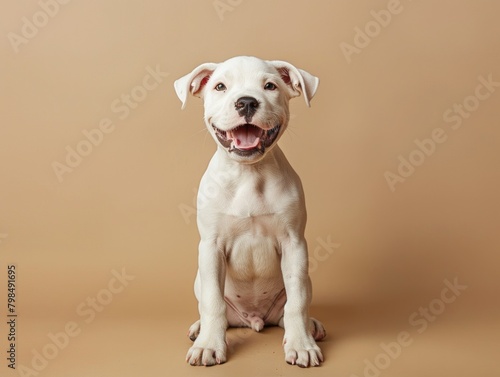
[186,337,227,366]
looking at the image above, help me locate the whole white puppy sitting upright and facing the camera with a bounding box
[175,57,326,367]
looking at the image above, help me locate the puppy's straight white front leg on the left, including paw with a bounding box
[186,240,227,365]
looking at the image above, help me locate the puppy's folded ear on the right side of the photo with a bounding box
[269,60,319,106]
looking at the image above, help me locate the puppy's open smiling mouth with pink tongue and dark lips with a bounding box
[212,123,281,156]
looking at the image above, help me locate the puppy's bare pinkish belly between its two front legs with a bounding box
[224,234,286,329]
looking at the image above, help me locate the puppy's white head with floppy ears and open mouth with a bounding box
[175,56,319,163]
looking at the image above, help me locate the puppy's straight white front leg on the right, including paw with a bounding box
[281,237,323,367]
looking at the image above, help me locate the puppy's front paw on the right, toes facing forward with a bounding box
[283,334,323,368]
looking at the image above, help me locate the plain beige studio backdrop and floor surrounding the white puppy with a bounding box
[0,0,500,377]
